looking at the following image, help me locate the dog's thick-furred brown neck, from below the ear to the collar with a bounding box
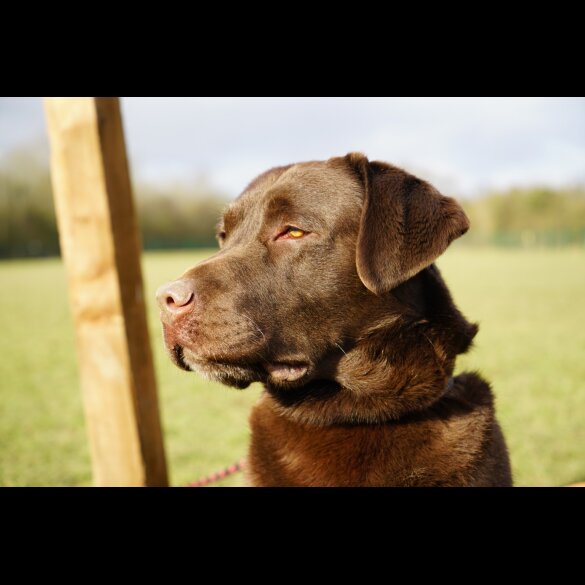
[266,266,477,425]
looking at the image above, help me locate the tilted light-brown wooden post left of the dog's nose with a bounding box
[45,98,167,486]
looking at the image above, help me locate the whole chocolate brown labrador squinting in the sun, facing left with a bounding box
[157,153,512,486]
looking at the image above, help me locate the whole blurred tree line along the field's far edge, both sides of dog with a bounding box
[0,149,585,258]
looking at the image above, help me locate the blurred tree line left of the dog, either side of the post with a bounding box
[0,145,228,258]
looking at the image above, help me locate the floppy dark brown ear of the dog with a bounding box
[345,153,469,295]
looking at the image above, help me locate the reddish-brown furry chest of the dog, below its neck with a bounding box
[248,400,488,486]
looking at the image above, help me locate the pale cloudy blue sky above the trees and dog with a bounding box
[0,98,585,196]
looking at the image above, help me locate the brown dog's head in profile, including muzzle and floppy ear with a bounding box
[157,153,469,418]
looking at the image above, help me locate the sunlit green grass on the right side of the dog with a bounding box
[439,248,585,485]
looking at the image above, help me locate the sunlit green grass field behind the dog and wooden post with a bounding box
[0,248,585,486]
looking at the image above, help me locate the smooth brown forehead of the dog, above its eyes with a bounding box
[224,161,363,225]
